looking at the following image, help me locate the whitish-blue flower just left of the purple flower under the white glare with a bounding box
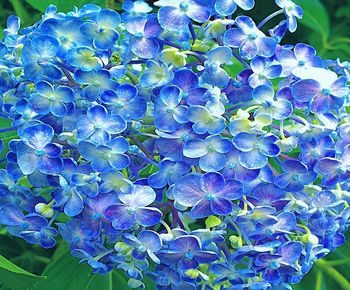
[252,85,293,120]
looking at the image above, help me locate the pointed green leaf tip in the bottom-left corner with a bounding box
[0,255,46,289]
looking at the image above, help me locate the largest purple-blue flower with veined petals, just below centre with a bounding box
[173,172,243,219]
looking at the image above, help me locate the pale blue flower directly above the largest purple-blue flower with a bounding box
[183,135,233,171]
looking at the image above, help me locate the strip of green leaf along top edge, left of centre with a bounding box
[26,0,106,12]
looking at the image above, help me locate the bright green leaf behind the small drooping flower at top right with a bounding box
[294,0,330,42]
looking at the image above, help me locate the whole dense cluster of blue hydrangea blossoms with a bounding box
[0,0,350,290]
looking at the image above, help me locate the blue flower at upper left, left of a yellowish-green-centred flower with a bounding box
[21,35,62,81]
